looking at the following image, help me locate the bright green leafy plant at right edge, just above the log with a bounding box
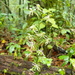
[59,44,75,68]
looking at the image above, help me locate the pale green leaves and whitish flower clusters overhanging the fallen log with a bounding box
[31,50,52,75]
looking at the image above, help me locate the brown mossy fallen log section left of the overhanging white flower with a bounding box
[0,55,32,75]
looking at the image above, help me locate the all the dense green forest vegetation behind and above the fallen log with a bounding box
[0,0,75,75]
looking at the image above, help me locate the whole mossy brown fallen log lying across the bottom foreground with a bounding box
[0,55,73,75]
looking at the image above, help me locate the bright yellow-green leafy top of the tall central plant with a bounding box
[30,5,58,33]
